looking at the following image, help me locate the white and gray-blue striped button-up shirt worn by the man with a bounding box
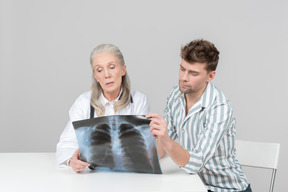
[164,82,248,192]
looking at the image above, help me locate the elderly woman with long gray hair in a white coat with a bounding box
[56,44,149,172]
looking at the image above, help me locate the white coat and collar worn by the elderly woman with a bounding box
[56,91,150,166]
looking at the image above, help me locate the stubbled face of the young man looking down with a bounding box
[179,59,215,94]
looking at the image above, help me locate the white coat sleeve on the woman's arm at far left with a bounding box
[56,94,86,167]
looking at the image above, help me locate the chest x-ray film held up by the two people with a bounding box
[73,115,162,174]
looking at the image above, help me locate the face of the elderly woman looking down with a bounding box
[92,52,126,101]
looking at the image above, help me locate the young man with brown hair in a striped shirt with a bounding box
[146,40,251,192]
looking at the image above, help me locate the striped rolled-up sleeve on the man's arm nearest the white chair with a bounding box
[182,103,234,173]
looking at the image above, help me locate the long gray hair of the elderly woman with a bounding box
[90,44,131,117]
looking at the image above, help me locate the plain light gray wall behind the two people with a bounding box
[0,0,288,191]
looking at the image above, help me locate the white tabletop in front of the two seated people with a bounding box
[0,153,207,192]
